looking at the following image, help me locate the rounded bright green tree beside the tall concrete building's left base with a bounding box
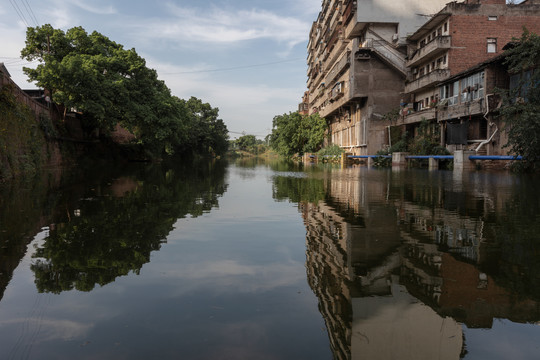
[270,111,327,158]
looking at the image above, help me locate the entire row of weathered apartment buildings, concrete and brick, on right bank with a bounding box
[307,0,540,155]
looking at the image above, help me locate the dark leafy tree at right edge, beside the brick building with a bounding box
[501,29,540,170]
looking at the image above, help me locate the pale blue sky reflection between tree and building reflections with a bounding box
[0,165,331,359]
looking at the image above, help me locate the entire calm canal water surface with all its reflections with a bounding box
[0,160,540,360]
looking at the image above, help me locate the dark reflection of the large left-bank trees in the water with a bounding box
[31,163,226,293]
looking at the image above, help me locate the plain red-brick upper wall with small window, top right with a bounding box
[448,0,540,75]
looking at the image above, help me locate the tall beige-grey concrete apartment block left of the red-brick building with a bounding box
[307,0,447,154]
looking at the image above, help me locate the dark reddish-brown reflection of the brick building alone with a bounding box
[400,201,540,328]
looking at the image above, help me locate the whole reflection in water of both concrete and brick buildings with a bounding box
[301,169,539,359]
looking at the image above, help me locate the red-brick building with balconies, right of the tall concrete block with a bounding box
[398,0,540,154]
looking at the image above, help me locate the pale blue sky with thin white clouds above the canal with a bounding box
[0,0,321,138]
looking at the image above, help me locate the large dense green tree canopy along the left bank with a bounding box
[21,25,228,155]
